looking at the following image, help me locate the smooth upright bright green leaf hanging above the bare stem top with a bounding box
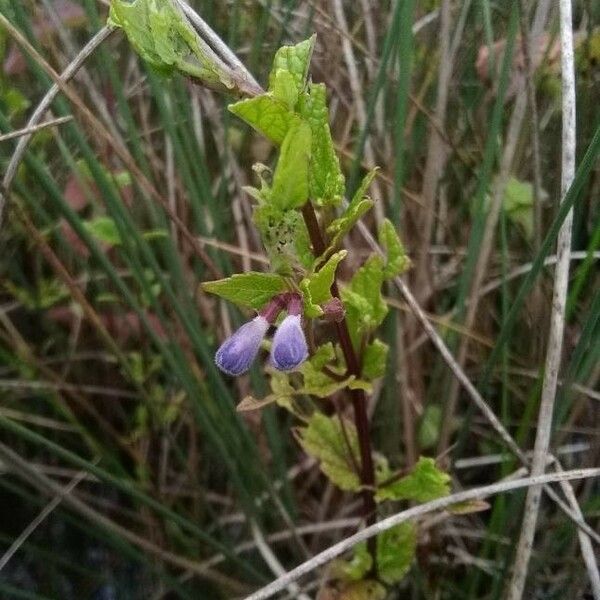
[271,119,311,210]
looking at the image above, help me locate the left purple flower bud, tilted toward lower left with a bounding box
[215,315,269,375]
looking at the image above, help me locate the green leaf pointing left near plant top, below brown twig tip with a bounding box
[229,93,295,144]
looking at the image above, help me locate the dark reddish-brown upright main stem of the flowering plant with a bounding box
[302,202,377,569]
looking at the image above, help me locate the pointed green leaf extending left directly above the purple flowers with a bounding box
[201,271,287,310]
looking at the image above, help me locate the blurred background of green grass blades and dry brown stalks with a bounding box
[0,0,600,600]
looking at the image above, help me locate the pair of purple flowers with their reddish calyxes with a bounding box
[215,294,308,376]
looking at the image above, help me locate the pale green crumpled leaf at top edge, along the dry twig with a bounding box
[108,0,235,90]
